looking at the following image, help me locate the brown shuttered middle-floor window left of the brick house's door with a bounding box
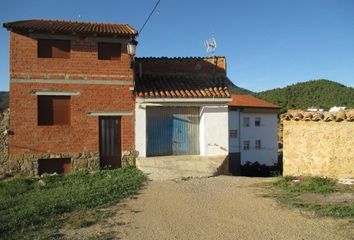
[38,96,70,125]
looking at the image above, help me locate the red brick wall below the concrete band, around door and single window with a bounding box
[9,83,134,154]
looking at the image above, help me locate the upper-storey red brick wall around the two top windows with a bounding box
[10,32,133,80]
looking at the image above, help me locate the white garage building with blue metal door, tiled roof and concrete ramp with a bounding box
[135,57,231,179]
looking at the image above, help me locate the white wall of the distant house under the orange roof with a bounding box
[229,111,278,165]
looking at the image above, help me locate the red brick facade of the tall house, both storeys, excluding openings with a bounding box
[9,32,135,155]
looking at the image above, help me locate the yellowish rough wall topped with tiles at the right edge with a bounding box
[283,110,354,178]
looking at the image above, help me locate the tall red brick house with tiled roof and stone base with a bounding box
[3,20,138,174]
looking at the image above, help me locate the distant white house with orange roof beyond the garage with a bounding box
[229,95,279,174]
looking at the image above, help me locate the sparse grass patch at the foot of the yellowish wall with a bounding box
[271,176,354,222]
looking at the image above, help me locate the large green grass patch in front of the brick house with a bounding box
[0,167,145,239]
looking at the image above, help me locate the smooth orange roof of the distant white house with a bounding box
[229,94,280,108]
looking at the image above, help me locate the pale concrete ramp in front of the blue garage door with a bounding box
[136,155,227,180]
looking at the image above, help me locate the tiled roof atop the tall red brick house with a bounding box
[3,19,138,36]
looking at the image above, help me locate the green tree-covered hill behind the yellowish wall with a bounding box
[255,79,354,111]
